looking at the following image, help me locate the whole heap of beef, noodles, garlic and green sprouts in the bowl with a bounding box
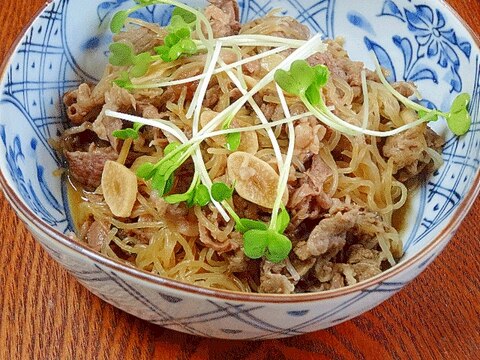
[57,0,470,293]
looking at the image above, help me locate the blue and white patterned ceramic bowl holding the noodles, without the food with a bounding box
[0,0,480,339]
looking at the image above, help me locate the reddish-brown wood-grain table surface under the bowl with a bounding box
[0,0,480,360]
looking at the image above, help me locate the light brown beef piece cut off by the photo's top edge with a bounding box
[205,0,240,38]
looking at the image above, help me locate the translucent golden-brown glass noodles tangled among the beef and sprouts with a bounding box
[64,4,441,292]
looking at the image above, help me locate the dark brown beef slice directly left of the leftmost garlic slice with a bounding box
[65,146,118,190]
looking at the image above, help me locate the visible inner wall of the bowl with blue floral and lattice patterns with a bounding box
[0,0,480,272]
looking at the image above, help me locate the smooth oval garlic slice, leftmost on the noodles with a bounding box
[102,160,138,217]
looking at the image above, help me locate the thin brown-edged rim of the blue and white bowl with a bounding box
[0,0,480,304]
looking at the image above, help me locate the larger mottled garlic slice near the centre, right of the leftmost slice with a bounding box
[227,151,288,209]
